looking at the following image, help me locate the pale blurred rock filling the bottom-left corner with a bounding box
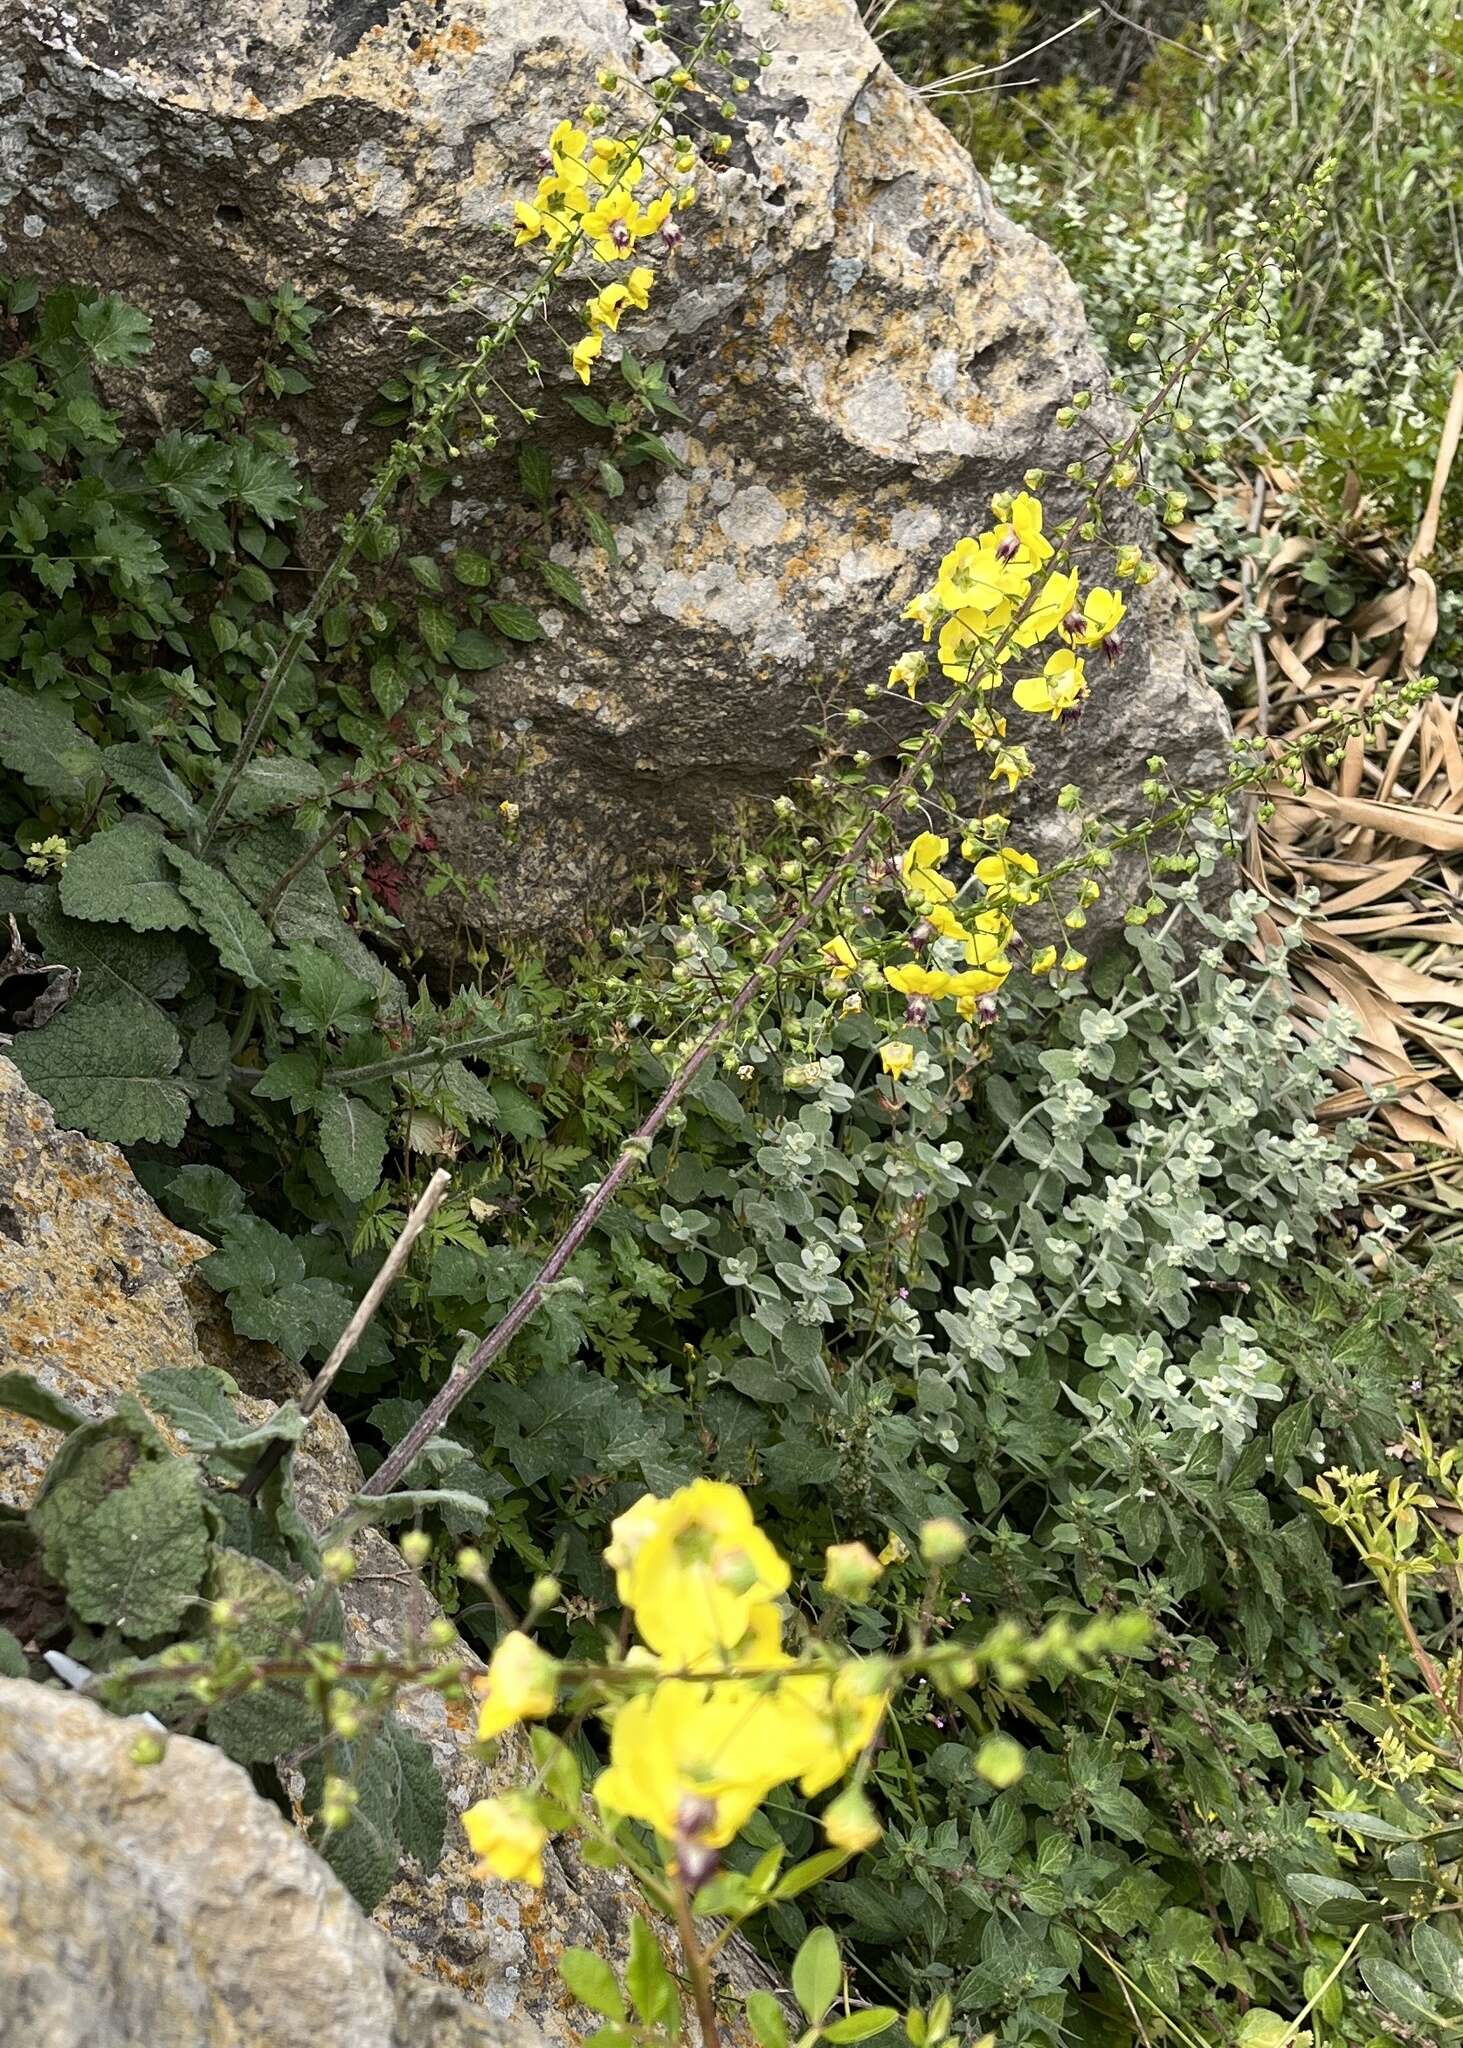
[0,1679,524,2048]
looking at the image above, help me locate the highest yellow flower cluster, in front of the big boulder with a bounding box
[514,109,697,383]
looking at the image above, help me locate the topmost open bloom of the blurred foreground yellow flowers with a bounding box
[604,1479,791,1665]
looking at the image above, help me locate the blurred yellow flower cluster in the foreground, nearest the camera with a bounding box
[463,1479,891,1888]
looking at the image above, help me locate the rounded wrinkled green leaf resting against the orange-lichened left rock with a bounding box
[66,1458,209,1640]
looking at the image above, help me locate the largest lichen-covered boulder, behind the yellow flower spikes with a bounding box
[0,0,1223,936]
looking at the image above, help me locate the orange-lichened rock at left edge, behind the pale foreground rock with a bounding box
[0,1059,764,2048]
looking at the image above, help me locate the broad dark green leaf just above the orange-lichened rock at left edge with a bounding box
[10,995,189,1145]
